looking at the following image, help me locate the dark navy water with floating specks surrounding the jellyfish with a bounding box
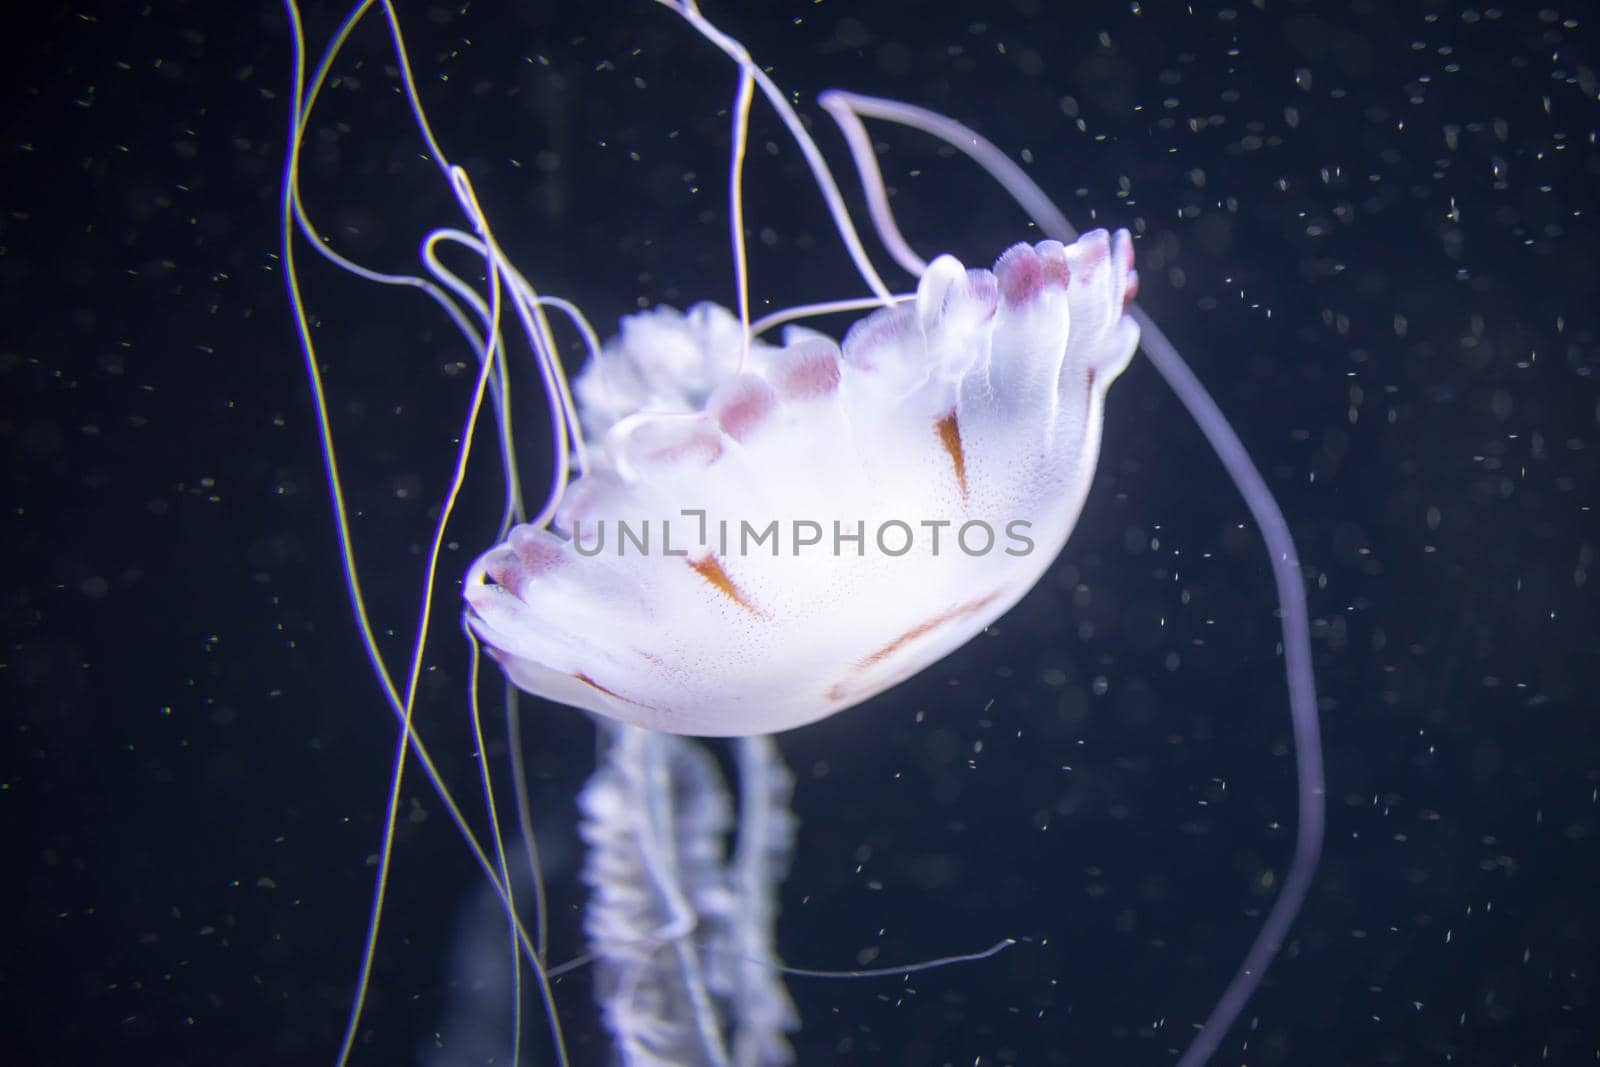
[0,0,1600,1065]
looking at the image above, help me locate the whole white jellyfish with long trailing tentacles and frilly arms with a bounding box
[282,0,1323,1067]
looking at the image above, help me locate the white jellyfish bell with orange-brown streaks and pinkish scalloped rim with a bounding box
[466,230,1139,736]
